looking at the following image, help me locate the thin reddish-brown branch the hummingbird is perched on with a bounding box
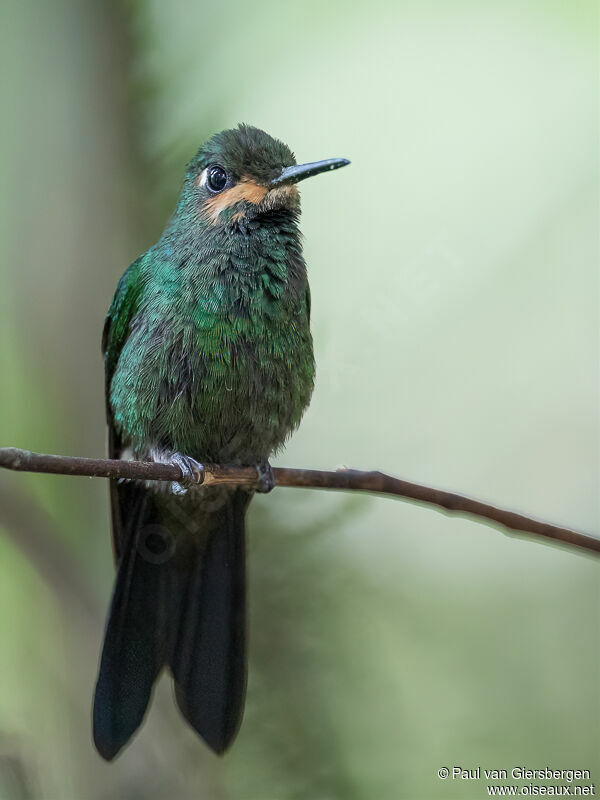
[0,447,600,555]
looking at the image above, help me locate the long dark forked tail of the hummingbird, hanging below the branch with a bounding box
[94,484,250,760]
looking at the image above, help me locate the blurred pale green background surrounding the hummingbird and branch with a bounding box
[0,0,600,800]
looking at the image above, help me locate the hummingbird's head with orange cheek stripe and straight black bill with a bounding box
[186,125,350,226]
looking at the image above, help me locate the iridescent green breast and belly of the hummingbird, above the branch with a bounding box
[109,247,314,463]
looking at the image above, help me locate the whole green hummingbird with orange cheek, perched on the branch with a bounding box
[93,125,350,760]
